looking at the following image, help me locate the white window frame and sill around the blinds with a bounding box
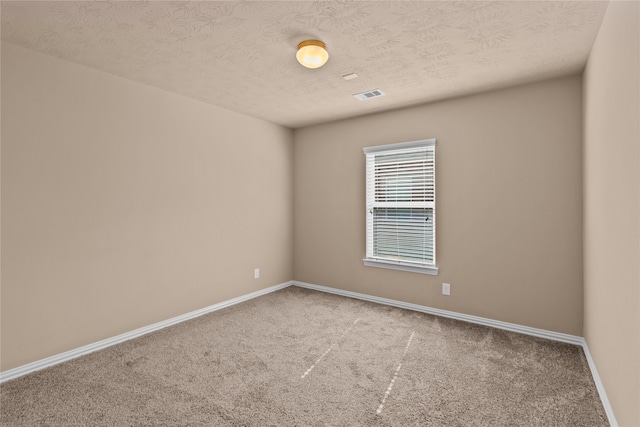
[362,138,438,275]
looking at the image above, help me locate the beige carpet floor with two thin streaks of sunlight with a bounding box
[0,287,608,426]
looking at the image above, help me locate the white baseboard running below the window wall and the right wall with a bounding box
[291,280,618,427]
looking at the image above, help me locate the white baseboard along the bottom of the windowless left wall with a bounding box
[0,282,293,383]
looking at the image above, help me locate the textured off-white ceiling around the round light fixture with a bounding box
[1,1,607,128]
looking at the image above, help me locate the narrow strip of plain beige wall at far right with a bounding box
[584,1,640,426]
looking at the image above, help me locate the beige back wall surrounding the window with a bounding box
[294,76,582,335]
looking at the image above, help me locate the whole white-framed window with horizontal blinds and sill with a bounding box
[364,139,438,274]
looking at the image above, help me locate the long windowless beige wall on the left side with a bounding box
[0,44,293,371]
